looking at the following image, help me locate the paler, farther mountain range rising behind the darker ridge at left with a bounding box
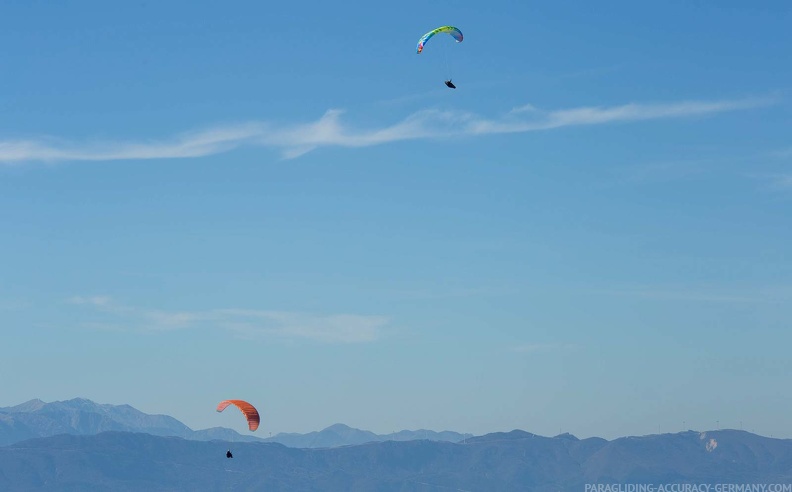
[0,398,470,448]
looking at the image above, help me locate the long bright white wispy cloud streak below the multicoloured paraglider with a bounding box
[0,98,775,164]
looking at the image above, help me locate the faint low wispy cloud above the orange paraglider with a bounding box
[69,296,389,343]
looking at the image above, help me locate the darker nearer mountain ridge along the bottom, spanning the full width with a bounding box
[0,430,792,492]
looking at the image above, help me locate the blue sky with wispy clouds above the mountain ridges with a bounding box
[0,0,792,438]
